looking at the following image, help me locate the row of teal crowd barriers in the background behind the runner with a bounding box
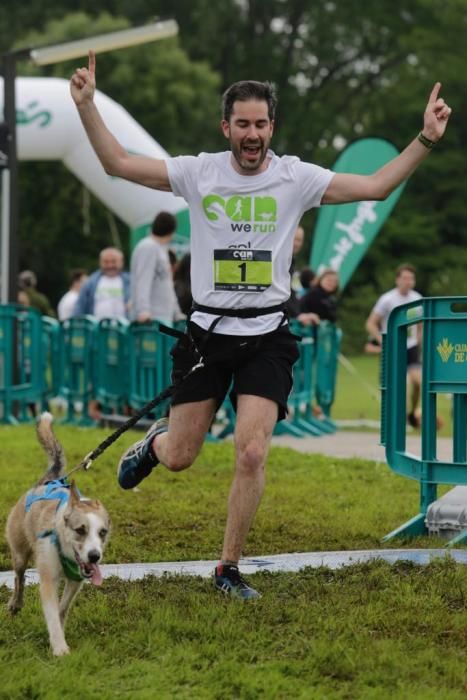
[0,305,341,438]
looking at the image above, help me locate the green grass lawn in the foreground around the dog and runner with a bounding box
[0,426,467,700]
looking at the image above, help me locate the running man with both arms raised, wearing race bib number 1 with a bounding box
[70,51,451,599]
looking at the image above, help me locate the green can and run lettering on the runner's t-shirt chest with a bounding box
[203,194,277,233]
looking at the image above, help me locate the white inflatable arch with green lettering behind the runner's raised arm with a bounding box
[0,78,189,247]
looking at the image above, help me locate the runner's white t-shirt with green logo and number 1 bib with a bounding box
[167,151,334,335]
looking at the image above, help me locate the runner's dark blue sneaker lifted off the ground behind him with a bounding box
[117,418,169,489]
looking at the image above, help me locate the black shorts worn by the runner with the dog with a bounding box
[171,323,299,420]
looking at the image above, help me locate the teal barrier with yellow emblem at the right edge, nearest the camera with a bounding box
[381,297,467,544]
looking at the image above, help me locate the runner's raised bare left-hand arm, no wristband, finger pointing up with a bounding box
[70,51,171,192]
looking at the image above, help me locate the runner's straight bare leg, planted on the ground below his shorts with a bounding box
[222,395,278,563]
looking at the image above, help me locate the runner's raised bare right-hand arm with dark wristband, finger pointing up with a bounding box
[322,83,452,204]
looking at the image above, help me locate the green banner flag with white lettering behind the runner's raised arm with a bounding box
[310,138,405,290]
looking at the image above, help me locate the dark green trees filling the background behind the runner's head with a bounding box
[0,0,467,320]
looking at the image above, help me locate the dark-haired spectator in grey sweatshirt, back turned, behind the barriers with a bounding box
[130,211,182,324]
